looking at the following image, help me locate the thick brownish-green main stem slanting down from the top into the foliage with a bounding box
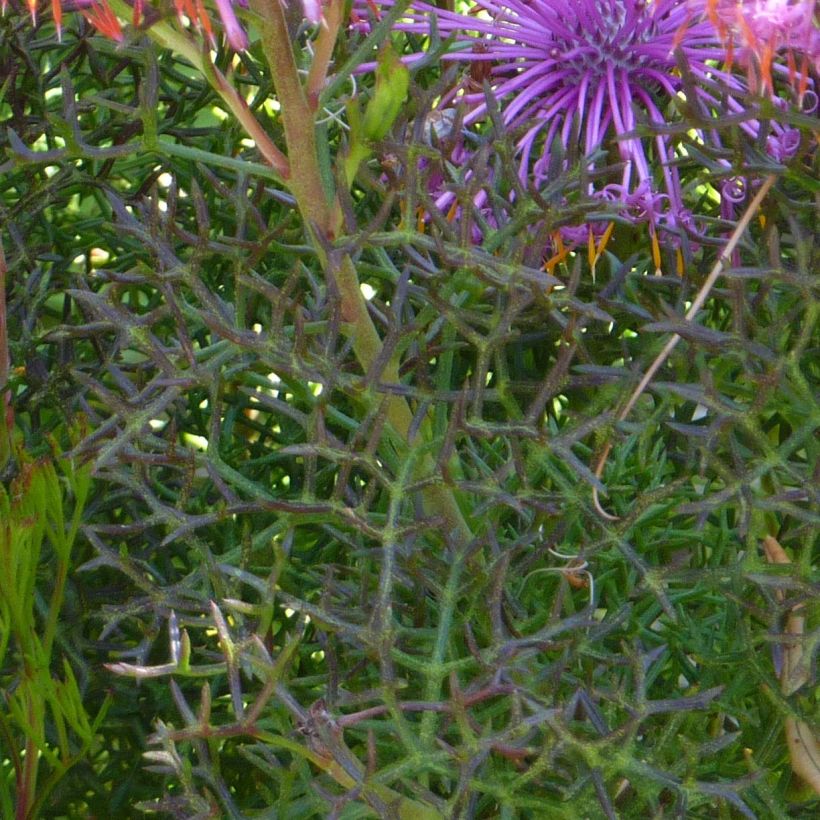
[251,0,473,546]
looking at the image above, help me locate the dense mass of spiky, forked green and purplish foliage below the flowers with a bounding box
[0,8,820,820]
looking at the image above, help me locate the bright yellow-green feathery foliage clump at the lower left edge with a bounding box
[0,432,106,817]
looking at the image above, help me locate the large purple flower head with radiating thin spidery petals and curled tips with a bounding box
[358,0,808,253]
